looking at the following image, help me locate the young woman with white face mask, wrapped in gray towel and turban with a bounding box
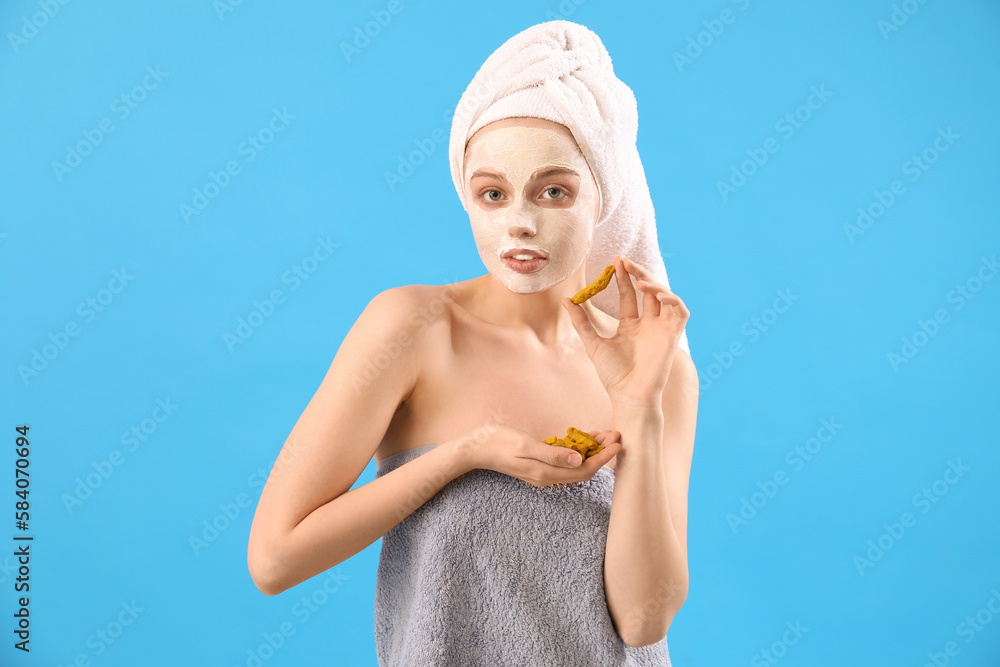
[248,21,698,667]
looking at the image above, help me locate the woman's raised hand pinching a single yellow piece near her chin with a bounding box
[562,255,690,405]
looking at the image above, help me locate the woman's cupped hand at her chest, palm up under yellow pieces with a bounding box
[455,423,622,486]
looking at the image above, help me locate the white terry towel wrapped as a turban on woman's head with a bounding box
[448,21,690,354]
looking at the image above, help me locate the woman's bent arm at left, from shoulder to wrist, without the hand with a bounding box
[247,287,467,595]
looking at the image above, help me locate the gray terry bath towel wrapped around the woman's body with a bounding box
[375,445,670,667]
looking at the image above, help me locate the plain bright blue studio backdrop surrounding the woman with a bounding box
[0,0,1000,667]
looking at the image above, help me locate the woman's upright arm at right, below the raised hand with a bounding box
[604,350,698,646]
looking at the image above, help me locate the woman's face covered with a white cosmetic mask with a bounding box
[465,118,600,294]
